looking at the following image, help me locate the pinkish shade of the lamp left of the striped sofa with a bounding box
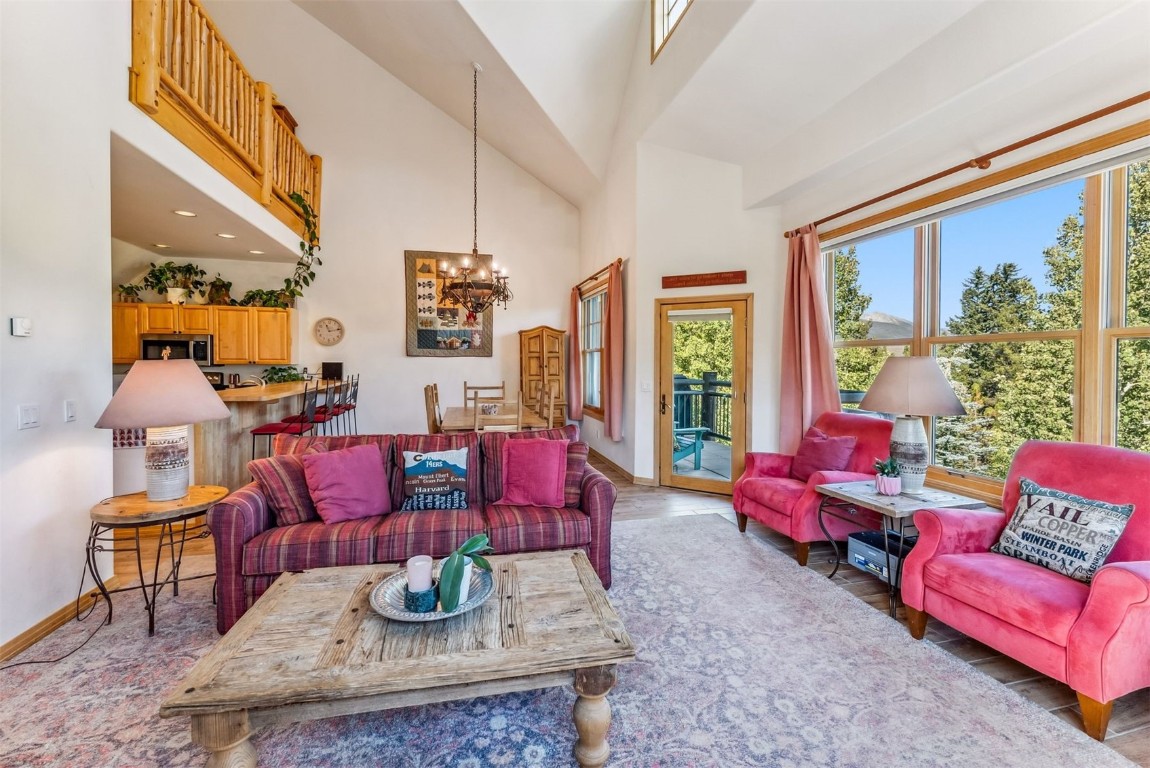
[95,360,230,429]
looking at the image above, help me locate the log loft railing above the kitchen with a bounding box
[129,0,322,235]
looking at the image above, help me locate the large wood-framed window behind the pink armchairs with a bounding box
[825,160,1150,489]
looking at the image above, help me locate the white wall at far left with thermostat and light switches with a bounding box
[0,2,121,642]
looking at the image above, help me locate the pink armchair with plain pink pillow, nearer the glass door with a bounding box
[733,413,891,566]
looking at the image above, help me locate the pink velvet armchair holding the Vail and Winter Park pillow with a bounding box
[903,440,1150,740]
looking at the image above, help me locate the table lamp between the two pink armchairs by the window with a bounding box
[859,355,966,492]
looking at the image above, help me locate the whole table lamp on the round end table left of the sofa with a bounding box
[95,360,231,501]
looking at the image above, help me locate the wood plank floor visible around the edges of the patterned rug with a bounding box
[116,467,1150,767]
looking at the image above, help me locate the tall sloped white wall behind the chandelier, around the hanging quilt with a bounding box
[206,2,580,432]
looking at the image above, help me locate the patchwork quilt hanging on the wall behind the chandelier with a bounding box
[404,251,493,358]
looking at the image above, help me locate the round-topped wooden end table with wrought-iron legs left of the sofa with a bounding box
[77,485,228,636]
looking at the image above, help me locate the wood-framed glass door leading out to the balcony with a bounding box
[656,294,752,494]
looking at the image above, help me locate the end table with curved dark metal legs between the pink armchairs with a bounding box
[814,481,986,619]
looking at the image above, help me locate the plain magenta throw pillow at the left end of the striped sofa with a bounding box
[302,444,391,525]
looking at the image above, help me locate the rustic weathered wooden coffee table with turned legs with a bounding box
[160,551,635,768]
